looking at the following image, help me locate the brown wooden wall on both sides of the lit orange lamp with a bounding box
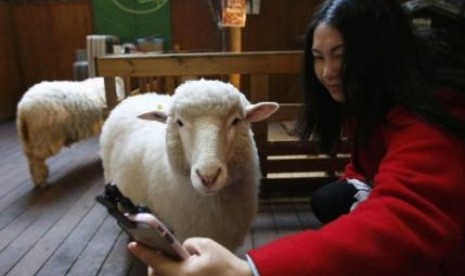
[171,0,322,51]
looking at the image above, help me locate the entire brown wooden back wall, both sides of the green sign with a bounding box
[0,0,321,122]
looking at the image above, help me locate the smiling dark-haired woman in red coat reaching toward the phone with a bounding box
[129,0,465,276]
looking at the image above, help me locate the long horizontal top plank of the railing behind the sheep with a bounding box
[97,51,302,77]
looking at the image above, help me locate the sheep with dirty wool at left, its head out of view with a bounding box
[16,78,124,186]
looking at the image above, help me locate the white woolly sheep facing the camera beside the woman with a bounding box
[100,80,278,250]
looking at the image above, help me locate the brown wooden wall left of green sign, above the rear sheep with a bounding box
[0,0,92,121]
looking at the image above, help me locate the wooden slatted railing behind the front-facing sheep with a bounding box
[96,51,350,198]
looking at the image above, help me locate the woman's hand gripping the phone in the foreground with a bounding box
[128,238,252,276]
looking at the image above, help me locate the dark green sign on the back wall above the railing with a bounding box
[92,0,171,49]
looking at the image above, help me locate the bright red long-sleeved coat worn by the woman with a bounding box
[248,108,465,276]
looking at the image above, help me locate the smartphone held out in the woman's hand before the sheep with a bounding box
[96,183,190,260]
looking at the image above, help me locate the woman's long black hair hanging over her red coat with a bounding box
[297,0,465,152]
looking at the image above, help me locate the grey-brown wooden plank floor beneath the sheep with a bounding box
[0,122,319,276]
